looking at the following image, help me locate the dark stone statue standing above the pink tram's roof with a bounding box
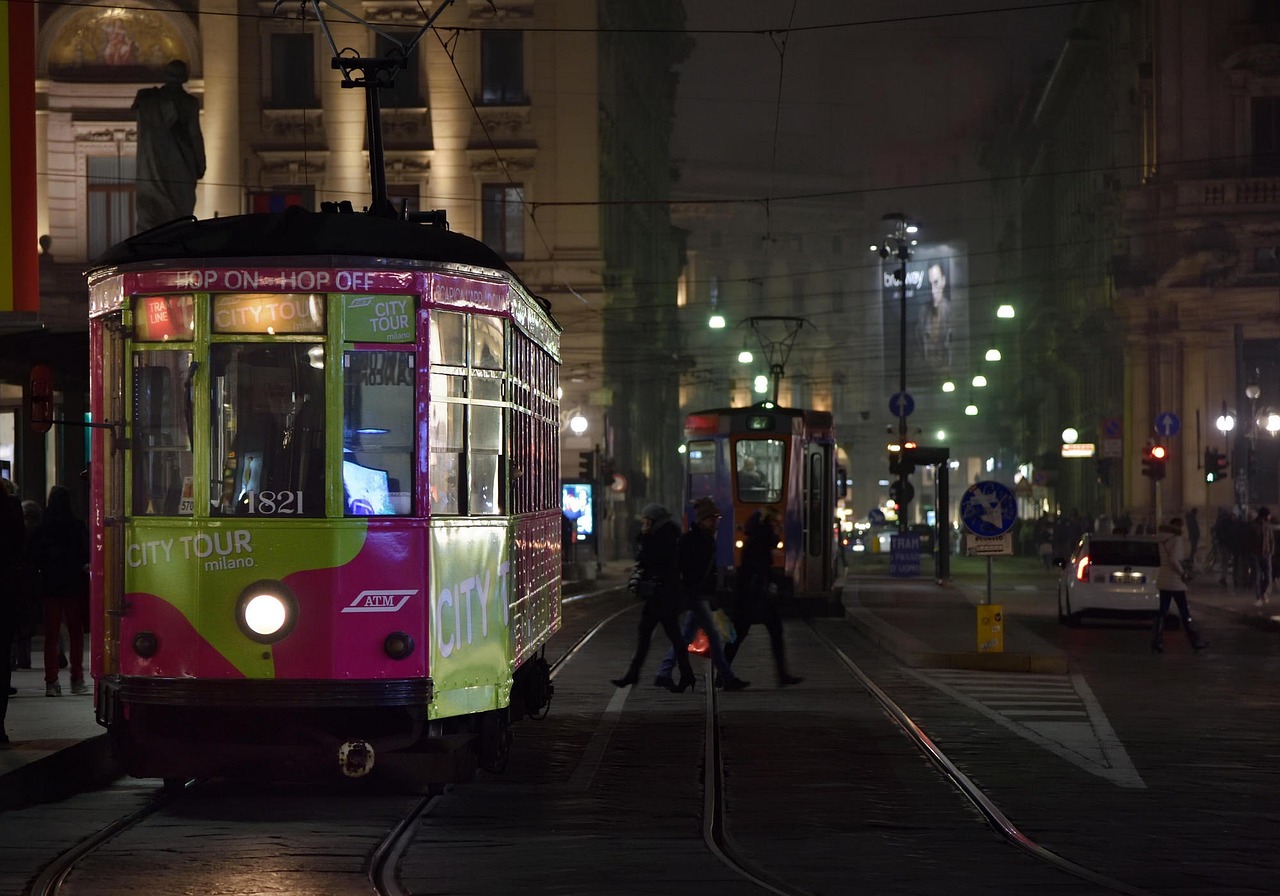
[133,59,205,232]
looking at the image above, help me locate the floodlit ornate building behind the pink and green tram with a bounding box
[0,0,682,552]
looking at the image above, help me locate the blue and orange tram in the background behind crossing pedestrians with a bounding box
[684,402,844,614]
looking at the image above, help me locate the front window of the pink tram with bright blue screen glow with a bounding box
[342,351,415,516]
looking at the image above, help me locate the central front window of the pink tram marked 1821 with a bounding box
[209,343,324,516]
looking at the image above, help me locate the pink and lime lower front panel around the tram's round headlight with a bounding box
[120,521,426,678]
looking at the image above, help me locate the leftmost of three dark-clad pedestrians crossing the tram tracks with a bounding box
[612,504,695,692]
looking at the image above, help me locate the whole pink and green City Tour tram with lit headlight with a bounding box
[81,209,561,783]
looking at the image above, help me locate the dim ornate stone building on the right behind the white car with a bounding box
[988,0,1280,525]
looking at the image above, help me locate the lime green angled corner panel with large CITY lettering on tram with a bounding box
[430,524,515,718]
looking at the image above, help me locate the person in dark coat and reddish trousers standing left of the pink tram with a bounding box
[36,485,88,696]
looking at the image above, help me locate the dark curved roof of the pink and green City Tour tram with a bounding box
[92,207,515,275]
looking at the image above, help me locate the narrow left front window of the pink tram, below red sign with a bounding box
[132,351,196,516]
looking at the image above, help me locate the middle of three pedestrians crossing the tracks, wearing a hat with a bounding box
[653,497,751,691]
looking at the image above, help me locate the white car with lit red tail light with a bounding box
[1057,535,1176,626]
